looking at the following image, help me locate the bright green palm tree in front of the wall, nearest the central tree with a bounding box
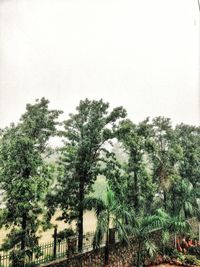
[83,189,132,266]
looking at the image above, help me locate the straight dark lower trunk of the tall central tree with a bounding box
[78,181,84,252]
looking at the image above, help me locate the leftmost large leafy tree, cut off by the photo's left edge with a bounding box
[0,98,60,266]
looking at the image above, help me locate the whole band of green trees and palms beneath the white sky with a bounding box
[0,98,200,264]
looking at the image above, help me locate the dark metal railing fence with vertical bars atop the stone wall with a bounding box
[0,232,108,267]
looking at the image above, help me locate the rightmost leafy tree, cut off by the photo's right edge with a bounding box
[175,123,200,242]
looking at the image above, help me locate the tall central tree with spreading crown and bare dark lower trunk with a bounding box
[57,99,126,250]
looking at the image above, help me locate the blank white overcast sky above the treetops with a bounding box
[0,0,200,130]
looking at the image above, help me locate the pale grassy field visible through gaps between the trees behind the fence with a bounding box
[0,176,107,245]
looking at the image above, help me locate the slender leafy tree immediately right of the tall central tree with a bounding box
[115,118,155,214]
